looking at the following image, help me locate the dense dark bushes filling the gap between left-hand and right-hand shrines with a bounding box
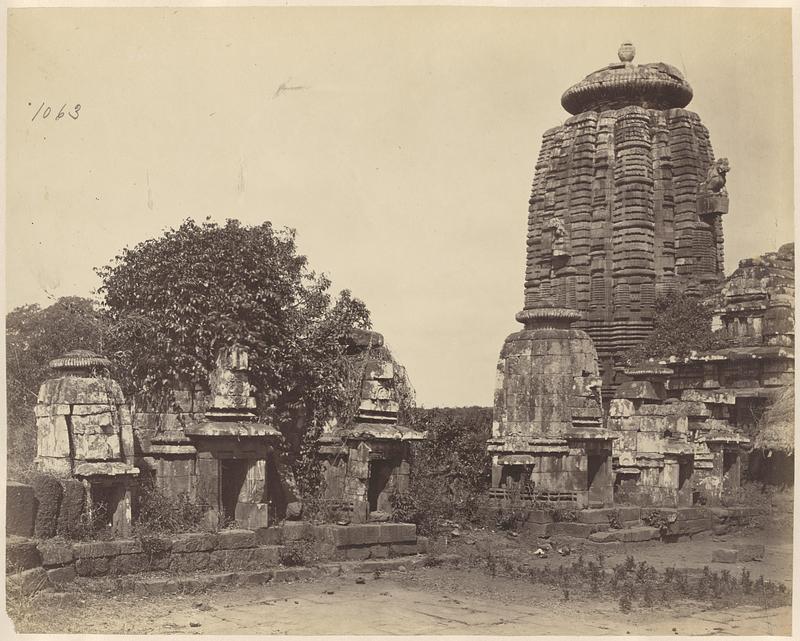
[392,407,492,536]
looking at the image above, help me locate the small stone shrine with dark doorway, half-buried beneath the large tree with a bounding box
[134,345,284,528]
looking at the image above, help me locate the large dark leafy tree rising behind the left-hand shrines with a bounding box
[97,219,369,456]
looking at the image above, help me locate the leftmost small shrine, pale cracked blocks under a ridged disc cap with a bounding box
[35,350,139,536]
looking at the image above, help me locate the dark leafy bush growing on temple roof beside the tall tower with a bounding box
[624,292,723,363]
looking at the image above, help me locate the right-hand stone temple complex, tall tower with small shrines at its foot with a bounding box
[488,43,794,507]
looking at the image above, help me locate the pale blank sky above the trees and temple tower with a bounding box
[6,7,794,407]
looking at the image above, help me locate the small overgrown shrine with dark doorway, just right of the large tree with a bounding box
[319,330,425,523]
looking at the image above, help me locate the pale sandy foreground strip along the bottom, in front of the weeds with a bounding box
[6,568,791,635]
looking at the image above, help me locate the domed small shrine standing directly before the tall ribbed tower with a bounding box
[488,300,613,507]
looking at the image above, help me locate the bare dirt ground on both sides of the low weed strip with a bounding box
[6,530,792,636]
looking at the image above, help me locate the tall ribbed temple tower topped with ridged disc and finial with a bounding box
[525,43,728,393]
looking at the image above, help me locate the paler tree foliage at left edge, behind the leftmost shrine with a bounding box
[6,296,104,471]
